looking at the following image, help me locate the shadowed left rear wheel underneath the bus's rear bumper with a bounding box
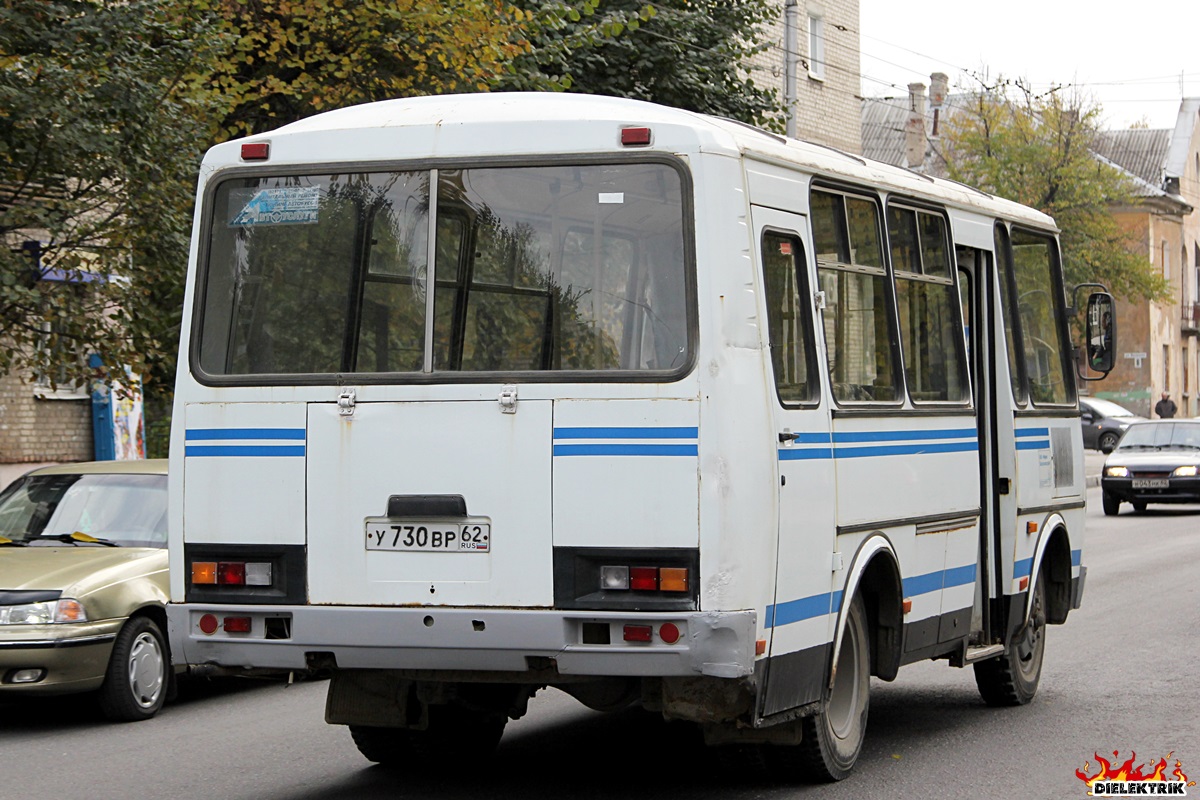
[350,705,509,772]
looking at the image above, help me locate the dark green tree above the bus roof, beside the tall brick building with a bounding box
[497,0,782,127]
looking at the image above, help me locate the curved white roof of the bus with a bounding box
[216,92,1056,229]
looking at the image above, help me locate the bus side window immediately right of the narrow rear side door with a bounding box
[811,190,900,403]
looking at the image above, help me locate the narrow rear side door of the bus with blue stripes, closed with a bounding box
[754,207,835,717]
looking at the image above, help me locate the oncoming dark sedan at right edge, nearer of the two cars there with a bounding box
[1100,420,1200,517]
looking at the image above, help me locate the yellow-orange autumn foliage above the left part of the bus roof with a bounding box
[198,0,533,137]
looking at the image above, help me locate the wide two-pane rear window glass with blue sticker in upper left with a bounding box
[197,163,691,379]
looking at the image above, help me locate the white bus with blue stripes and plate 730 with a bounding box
[169,94,1112,780]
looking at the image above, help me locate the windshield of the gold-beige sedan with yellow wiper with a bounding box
[0,475,167,548]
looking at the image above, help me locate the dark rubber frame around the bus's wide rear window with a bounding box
[187,152,700,386]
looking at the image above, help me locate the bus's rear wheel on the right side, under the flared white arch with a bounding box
[797,595,871,782]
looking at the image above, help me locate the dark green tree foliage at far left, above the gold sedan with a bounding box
[0,0,225,393]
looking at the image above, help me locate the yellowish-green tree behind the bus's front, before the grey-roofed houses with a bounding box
[942,82,1168,299]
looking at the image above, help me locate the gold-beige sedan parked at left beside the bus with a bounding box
[0,459,174,721]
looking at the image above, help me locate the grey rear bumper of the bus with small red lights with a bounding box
[167,603,757,678]
